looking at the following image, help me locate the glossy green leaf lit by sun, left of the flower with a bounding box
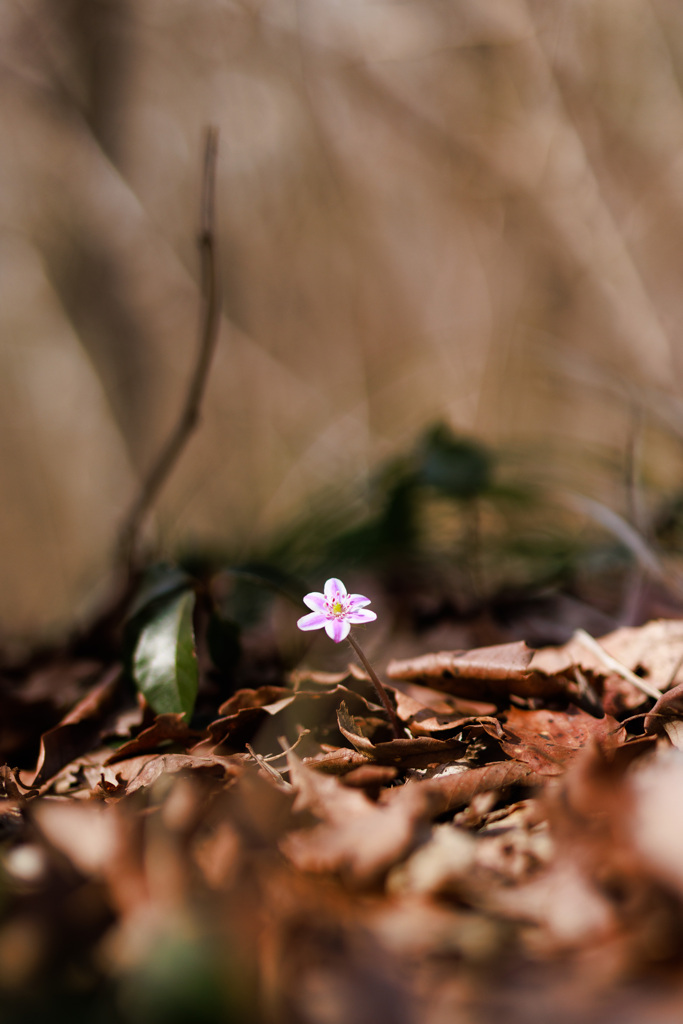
[133,590,198,718]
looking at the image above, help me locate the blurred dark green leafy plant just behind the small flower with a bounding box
[263,424,571,588]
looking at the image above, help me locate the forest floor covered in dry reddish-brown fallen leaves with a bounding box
[0,557,683,1024]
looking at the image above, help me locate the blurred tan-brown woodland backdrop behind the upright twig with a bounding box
[0,0,683,636]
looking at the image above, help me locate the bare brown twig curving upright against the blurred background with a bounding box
[117,128,220,570]
